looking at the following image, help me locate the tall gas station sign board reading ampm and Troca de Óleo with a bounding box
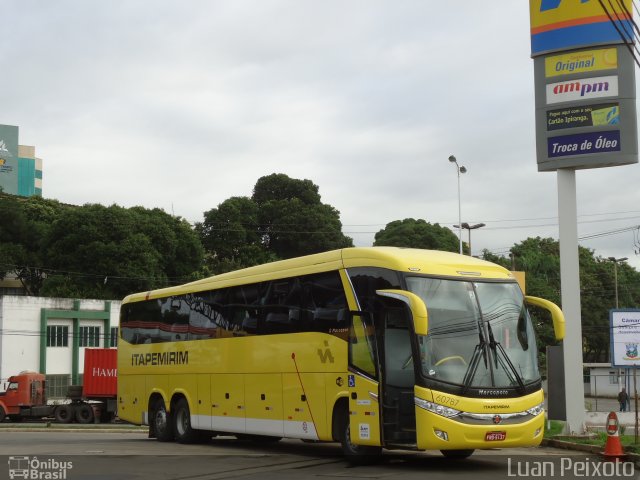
[529,0,638,172]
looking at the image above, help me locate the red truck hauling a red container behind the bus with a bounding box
[0,348,117,423]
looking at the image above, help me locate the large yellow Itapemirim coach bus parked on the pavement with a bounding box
[118,247,564,460]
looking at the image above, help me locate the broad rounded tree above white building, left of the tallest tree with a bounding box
[42,205,202,299]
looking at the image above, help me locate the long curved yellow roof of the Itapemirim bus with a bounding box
[123,247,514,303]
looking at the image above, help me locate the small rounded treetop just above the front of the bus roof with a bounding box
[373,218,460,252]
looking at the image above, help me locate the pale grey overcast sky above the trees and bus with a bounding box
[5,0,640,268]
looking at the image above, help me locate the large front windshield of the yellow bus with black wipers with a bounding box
[406,276,540,391]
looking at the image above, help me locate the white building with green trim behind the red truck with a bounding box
[0,295,121,398]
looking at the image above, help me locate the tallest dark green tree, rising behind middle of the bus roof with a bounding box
[196,173,353,273]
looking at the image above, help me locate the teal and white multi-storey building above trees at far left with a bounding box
[0,125,42,197]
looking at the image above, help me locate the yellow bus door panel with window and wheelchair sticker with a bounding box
[347,312,382,446]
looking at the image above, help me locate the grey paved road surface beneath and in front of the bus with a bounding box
[0,431,638,480]
